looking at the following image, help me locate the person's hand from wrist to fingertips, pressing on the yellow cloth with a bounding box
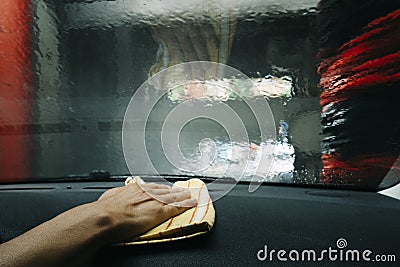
[93,183,197,243]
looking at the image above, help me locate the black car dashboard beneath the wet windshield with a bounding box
[0,182,400,266]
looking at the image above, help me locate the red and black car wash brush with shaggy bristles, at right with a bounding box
[318,1,400,190]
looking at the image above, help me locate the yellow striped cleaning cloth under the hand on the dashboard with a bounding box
[121,177,215,245]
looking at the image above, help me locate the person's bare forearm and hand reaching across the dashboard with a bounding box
[0,180,197,267]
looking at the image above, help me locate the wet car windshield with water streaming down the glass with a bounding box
[0,0,400,190]
